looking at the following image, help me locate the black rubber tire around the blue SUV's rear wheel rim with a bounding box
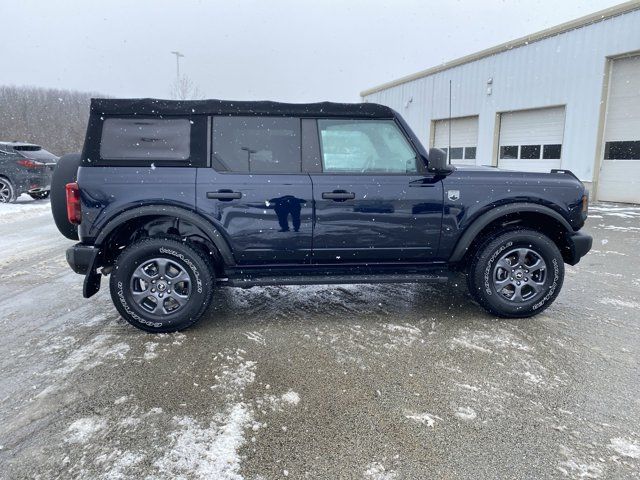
[109,237,215,333]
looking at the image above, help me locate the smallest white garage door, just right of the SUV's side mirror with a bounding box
[433,116,478,165]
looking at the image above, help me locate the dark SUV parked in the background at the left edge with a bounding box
[0,142,58,203]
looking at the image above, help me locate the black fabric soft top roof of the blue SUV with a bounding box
[91,98,396,118]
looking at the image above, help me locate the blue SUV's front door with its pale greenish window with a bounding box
[311,119,443,263]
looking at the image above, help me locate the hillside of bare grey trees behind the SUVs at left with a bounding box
[0,86,104,155]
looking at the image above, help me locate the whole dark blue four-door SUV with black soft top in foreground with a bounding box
[52,99,592,332]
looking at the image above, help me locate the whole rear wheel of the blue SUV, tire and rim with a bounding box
[109,237,215,333]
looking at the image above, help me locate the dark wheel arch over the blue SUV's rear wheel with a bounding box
[95,205,235,273]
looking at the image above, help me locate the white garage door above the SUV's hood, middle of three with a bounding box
[498,107,564,172]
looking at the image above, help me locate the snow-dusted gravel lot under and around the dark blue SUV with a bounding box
[0,200,640,480]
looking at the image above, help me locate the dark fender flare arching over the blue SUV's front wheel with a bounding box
[449,203,573,263]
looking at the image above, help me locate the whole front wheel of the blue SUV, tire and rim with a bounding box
[467,229,564,318]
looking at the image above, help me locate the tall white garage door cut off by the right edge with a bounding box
[598,56,640,203]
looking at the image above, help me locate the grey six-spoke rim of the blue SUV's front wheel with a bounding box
[493,248,547,303]
